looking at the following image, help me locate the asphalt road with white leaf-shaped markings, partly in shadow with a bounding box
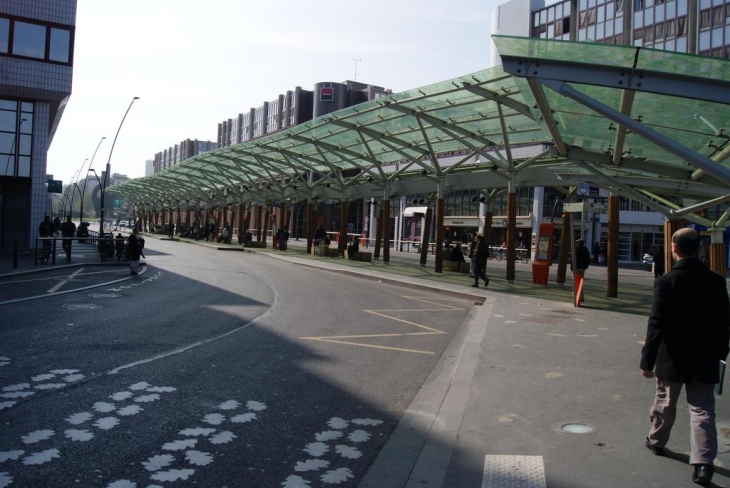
[0,240,472,488]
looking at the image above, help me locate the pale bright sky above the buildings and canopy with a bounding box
[47,0,503,185]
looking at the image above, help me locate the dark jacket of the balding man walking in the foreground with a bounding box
[641,258,730,384]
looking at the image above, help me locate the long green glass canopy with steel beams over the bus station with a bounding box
[109,36,730,226]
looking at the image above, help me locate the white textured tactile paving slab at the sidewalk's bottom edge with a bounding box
[482,455,547,488]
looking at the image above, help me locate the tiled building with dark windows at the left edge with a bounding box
[0,0,76,249]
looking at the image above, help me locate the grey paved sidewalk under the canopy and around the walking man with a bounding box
[0,235,730,488]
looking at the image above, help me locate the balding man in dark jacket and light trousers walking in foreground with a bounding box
[640,228,730,484]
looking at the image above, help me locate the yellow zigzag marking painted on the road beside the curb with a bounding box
[300,295,464,354]
